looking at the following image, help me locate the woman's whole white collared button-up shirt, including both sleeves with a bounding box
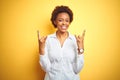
[40,33,84,80]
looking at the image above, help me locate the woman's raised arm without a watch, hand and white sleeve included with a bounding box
[37,31,51,72]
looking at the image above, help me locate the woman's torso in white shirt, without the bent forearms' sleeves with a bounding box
[39,33,84,80]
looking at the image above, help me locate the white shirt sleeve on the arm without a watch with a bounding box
[39,39,51,72]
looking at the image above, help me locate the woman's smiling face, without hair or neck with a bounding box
[54,12,70,33]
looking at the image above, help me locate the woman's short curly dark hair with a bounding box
[51,5,73,28]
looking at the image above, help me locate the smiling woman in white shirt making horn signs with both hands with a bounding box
[38,6,85,80]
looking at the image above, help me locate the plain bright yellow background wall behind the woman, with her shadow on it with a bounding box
[0,0,120,80]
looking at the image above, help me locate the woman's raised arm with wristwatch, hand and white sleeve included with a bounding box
[73,30,85,74]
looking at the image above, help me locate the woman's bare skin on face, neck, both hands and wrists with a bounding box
[38,12,85,55]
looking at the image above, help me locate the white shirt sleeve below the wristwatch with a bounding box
[73,53,84,74]
